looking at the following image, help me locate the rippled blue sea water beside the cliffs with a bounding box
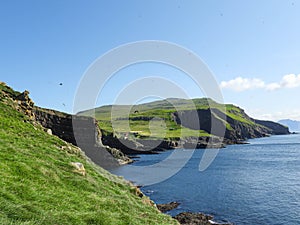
[113,134,300,225]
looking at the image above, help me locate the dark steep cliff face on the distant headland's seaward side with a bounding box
[172,108,289,142]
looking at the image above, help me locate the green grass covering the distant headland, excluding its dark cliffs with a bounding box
[78,98,254,139]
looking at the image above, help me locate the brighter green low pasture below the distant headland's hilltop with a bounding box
[96,109,210,139]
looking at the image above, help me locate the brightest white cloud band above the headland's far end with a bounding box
[220,74,300,92]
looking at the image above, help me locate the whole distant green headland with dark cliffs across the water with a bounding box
[78,98,289,150]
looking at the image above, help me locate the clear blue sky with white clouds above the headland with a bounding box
[0,0,300,121]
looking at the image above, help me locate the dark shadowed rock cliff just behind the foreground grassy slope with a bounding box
[33,107,132,169]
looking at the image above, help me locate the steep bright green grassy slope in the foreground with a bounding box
[0,91,176,225]
